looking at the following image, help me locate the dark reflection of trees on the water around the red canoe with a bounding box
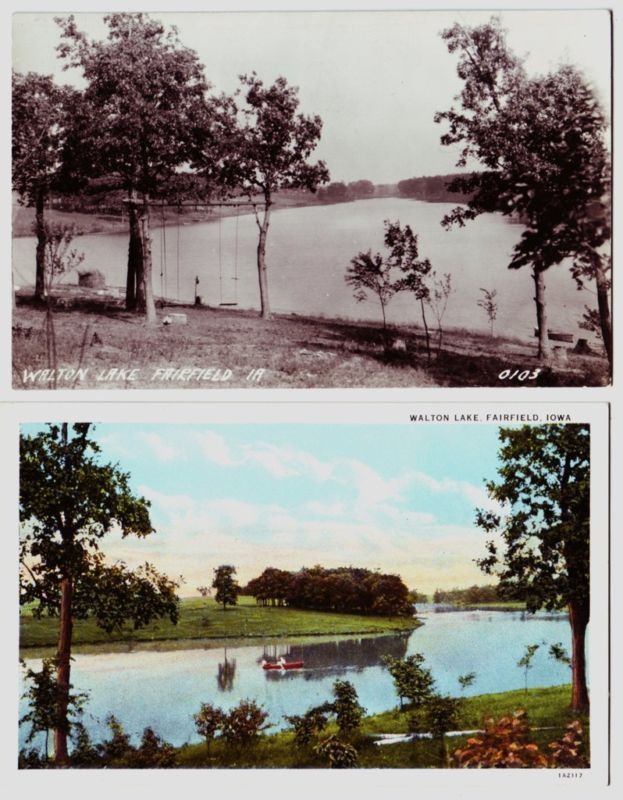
[258,631,411,681]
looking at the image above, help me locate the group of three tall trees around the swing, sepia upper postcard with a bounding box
[13,12,329,322]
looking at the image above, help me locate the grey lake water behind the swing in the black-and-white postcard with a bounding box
[13,198,594,339]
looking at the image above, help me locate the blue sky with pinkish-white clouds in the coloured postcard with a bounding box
[24,423,508,596]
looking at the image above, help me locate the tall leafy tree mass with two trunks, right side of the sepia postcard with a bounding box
[435,18,612,368]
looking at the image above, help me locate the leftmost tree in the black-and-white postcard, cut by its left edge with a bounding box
[12,72,78,301]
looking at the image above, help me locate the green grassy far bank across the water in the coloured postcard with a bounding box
[20,597,420,656]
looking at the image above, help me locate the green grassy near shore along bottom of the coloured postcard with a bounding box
[178,686,588,769]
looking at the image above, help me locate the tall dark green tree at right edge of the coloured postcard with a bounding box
[476,424,590,710]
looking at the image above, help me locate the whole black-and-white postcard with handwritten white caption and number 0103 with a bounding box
[12,8,612,390]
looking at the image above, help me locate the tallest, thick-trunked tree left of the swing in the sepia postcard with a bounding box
[57,13,209,322]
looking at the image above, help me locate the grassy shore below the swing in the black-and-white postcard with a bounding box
[13,296,608,389]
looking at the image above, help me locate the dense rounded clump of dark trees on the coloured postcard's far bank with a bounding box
[242,566,413,616]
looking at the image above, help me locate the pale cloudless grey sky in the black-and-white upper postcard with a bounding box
[13,9,611,183]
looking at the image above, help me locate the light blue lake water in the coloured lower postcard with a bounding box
[20,611,571,745]
